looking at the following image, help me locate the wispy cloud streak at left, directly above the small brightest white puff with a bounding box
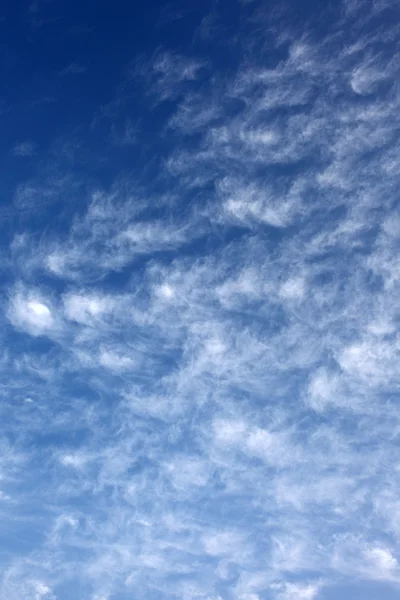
[22,183,208,282]
